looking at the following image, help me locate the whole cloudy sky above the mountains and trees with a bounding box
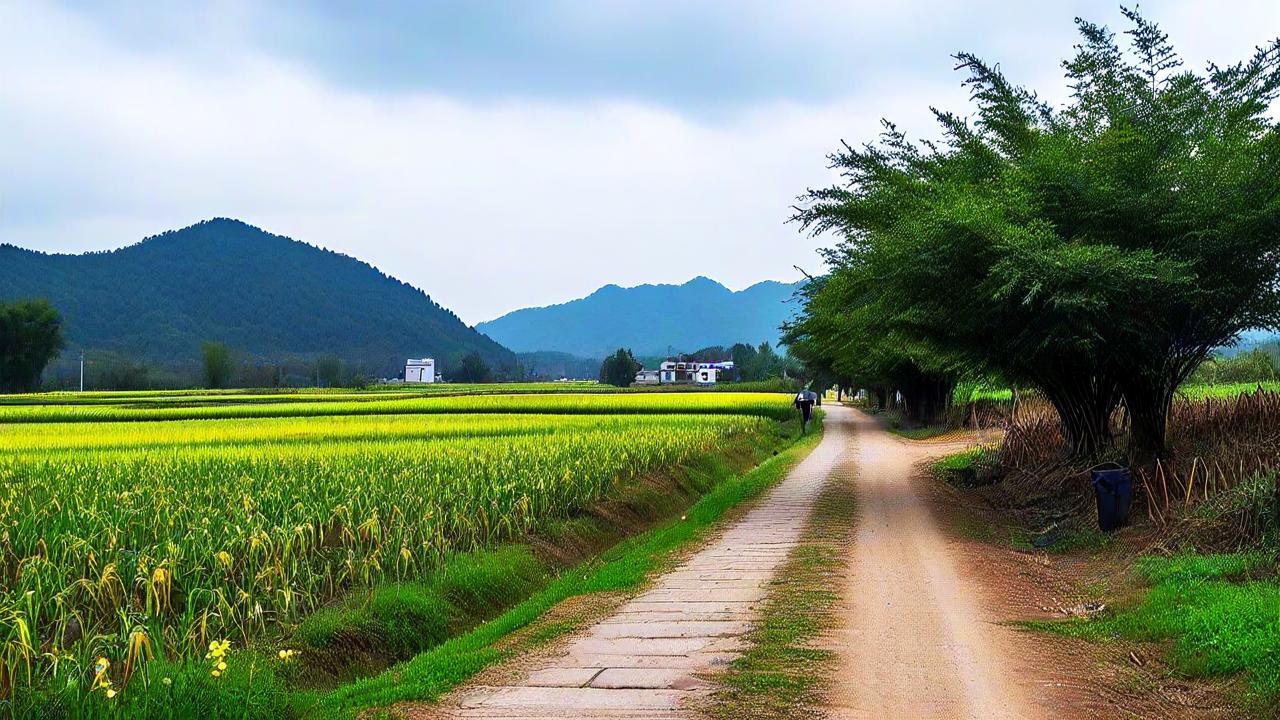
[0,0,1280,323]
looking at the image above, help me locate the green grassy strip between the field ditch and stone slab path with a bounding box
[303,420,820,719]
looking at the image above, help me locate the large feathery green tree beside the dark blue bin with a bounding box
[797,10,1280,460]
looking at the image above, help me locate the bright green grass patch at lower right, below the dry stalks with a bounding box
[1025,552,1280,717]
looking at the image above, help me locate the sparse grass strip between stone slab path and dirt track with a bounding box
[704,448,855,720]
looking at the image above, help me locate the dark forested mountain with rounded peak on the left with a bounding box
[0,218,516,373]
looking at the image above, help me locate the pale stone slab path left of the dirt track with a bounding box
[444,406,854,720]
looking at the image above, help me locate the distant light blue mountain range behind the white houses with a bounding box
[476,277,799,357]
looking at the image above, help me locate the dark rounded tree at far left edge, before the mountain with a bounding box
[0,300,65,392]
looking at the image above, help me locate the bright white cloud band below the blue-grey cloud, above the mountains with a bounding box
[0,4,1277,323]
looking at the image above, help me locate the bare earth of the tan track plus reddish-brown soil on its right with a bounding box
[829,407,1236,720]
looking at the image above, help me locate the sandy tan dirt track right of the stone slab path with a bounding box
[831,413,1062,720]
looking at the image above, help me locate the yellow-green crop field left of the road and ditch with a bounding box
[0,392,790,696]
